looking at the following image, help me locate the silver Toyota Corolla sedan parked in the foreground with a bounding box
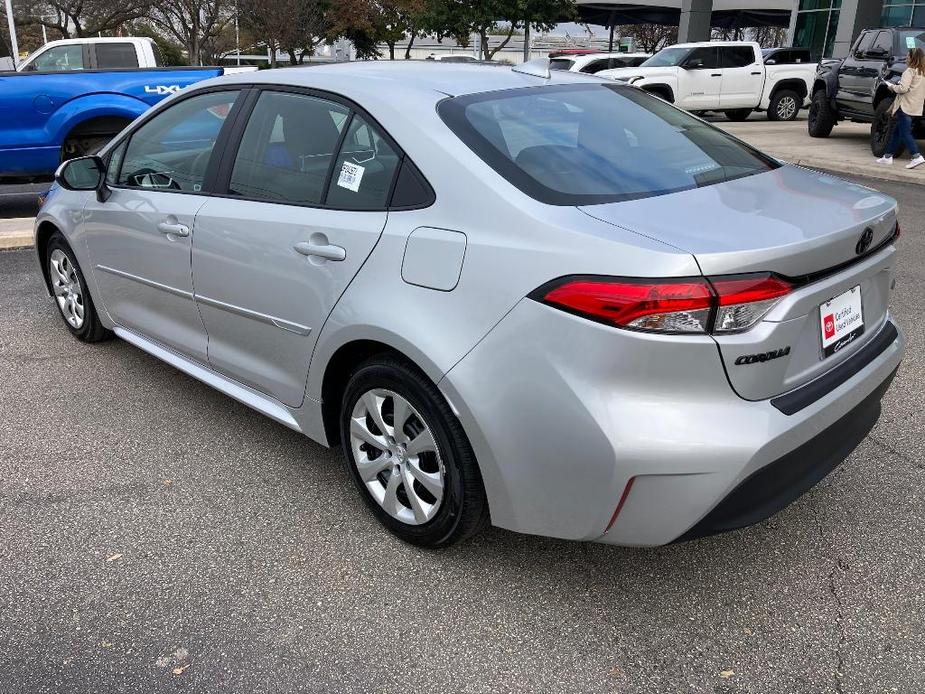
[35,61,904,546]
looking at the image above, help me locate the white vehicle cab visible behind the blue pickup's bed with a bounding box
[19,36,166,72]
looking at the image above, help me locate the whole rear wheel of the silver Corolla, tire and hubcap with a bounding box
[340,356,488,547]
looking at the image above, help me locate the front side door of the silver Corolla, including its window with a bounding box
[83,89,240,363]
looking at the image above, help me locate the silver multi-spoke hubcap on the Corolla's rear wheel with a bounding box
[350,388,446,525]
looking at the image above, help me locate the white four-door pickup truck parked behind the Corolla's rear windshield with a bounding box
[597,41,816,121]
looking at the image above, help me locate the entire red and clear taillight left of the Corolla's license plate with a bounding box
[530,273,792,334]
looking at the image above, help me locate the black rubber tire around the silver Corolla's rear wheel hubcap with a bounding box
[340,355,488,548]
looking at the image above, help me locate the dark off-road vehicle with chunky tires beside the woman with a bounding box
[809,27,925,157]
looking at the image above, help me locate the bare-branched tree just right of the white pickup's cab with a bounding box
[149,0,234,65]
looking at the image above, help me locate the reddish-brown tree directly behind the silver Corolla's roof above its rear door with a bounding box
[238,0,327,67]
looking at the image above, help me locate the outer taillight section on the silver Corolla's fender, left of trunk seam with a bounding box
[542,278,713,333]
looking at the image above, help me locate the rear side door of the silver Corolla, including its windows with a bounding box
[193,89,400,407]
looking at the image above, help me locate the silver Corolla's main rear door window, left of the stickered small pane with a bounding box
[228,91,350,205]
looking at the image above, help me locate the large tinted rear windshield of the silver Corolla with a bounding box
[439,84,779,205]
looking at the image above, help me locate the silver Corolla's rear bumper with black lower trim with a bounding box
[440,300,904,546]
